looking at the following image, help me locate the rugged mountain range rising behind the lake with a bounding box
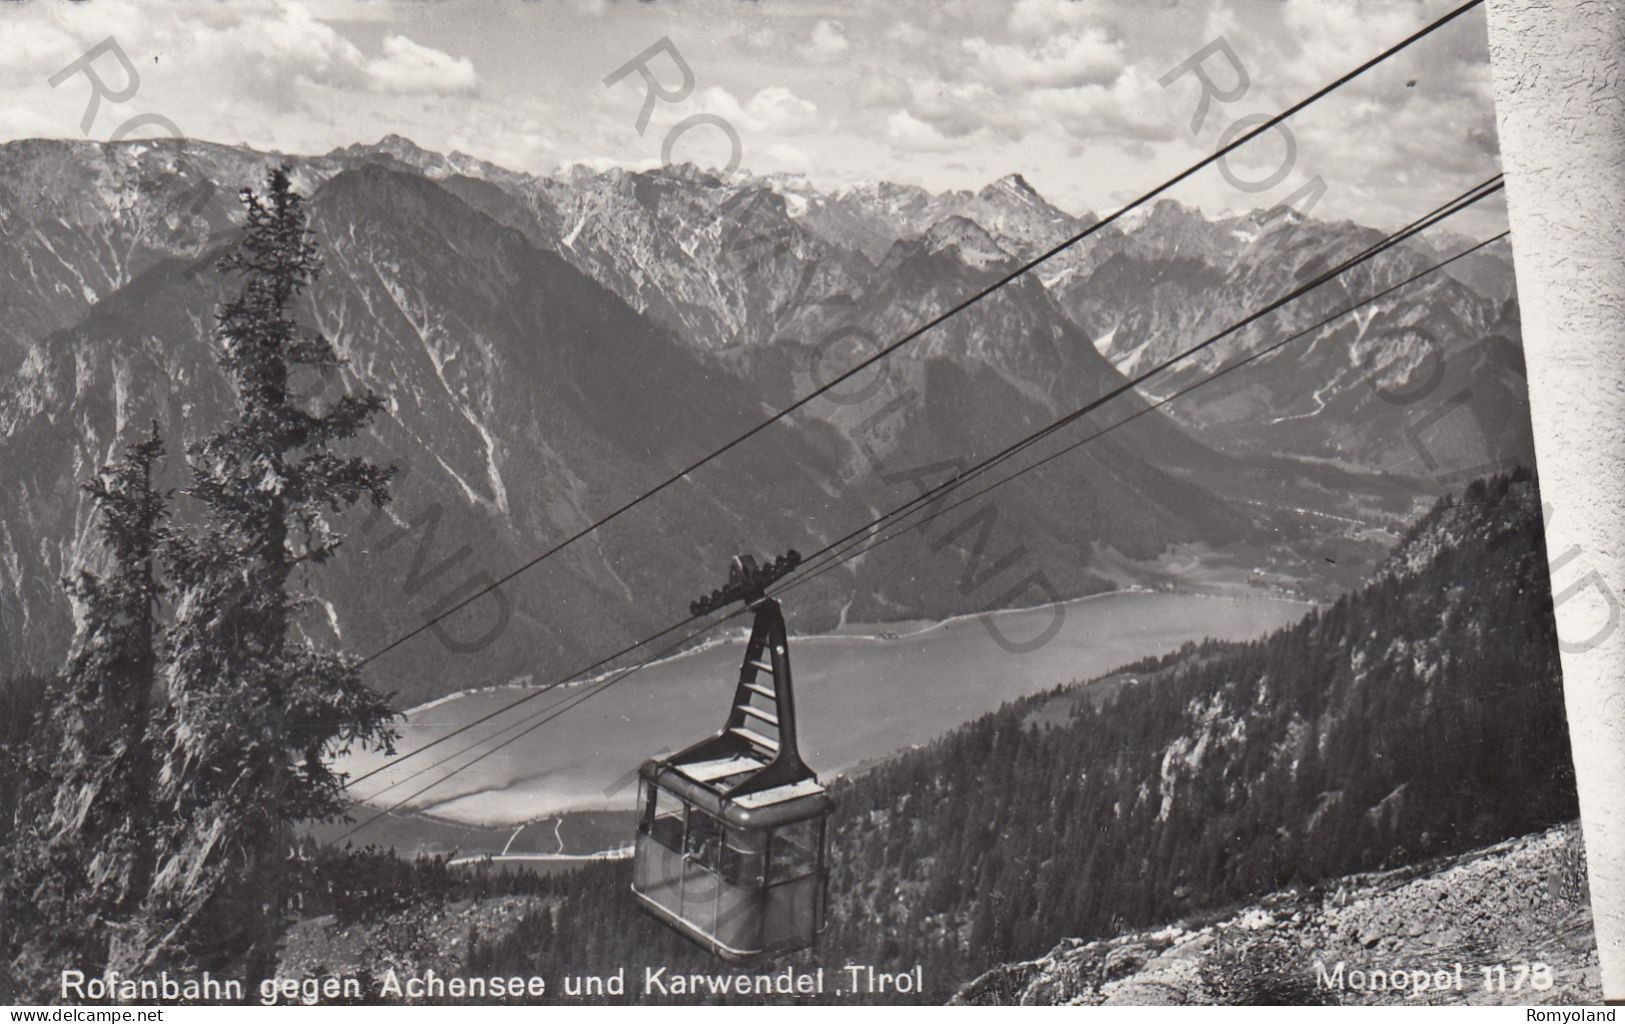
[0,137,1532,701]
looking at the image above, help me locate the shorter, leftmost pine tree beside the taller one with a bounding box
[3,423,169,994]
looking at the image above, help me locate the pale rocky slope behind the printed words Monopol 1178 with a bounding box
[954,824,1602,1004]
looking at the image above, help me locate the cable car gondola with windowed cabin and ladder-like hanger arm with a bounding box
[632,551,834,962]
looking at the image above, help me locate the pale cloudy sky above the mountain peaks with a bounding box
[0,0,1498,234]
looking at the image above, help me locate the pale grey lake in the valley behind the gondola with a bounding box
[340,592,1308,842]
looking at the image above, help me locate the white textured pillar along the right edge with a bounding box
[1489,0,1625,1000]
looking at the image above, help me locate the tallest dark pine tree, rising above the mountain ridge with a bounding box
[132,169,393,977]
